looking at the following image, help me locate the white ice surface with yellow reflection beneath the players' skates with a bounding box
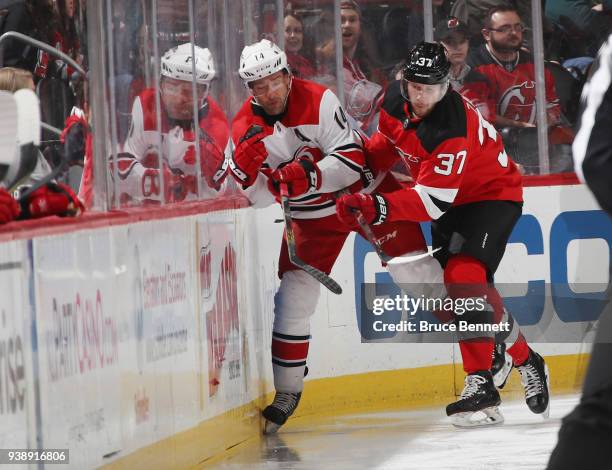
[214,395,579,470]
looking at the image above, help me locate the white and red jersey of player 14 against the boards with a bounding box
[232,77,384,219]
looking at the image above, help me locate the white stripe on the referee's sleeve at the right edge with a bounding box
[572,35,612,215]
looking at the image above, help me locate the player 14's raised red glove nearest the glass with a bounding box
[229,125,268,188]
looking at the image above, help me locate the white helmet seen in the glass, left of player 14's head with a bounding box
[161,42,215,84]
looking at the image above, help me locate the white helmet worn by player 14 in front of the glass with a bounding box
[238,39,290,86]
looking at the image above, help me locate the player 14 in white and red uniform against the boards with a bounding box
[229,40,441,432]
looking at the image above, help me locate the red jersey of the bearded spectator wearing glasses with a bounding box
[468,44,561,124]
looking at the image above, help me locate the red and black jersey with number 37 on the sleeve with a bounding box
[367,82,523,222]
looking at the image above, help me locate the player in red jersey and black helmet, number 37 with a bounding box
[337,42,549,426]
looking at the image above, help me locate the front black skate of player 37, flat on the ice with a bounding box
[446,370,504,427]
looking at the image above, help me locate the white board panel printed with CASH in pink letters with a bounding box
[33,230,120,468]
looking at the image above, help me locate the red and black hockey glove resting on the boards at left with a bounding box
[20,183,85,219]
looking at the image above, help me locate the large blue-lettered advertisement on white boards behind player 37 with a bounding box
[353,185,612,343]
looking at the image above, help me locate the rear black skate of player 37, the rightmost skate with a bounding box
[516,348,550,419]
